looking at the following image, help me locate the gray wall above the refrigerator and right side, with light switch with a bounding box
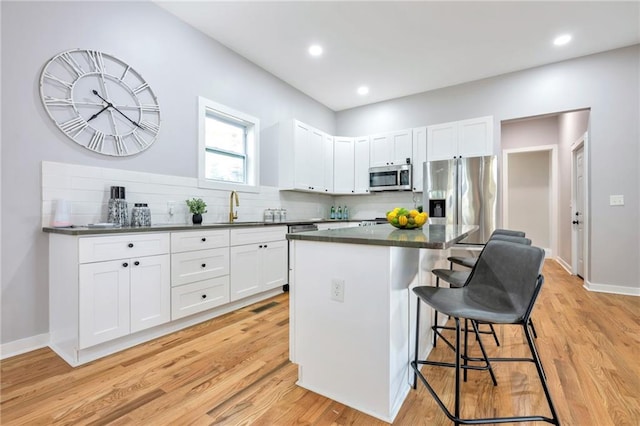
[336,45,640,291]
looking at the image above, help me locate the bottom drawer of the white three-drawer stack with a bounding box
[171,275,229,320]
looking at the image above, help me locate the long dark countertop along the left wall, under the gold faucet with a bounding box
[42,219,362,235]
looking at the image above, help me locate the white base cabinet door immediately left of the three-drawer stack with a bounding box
[130,253,170,333]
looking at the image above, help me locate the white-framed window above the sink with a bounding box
[198,98,260,192]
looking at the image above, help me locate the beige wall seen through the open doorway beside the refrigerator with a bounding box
[507,151,555,248]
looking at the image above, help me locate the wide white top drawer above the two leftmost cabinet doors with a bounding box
[78,232,169,263]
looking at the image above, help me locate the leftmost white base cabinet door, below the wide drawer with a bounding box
[78,260,130,349]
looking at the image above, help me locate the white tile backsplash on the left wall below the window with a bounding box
[42,161,336,226]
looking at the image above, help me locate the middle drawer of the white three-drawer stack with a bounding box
[171,247,229,286]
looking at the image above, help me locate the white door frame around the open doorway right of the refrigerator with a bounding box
[502,145,559,258]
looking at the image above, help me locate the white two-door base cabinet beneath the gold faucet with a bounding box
[230,226,288,301]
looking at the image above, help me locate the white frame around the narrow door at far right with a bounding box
[571,134,590,283]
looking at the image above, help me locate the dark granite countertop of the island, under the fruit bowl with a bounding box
[287,224,478,249]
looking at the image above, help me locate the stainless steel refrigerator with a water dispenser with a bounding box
[422,156,498,244]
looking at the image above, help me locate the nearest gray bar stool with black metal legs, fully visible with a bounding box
[411,240,560,426]
